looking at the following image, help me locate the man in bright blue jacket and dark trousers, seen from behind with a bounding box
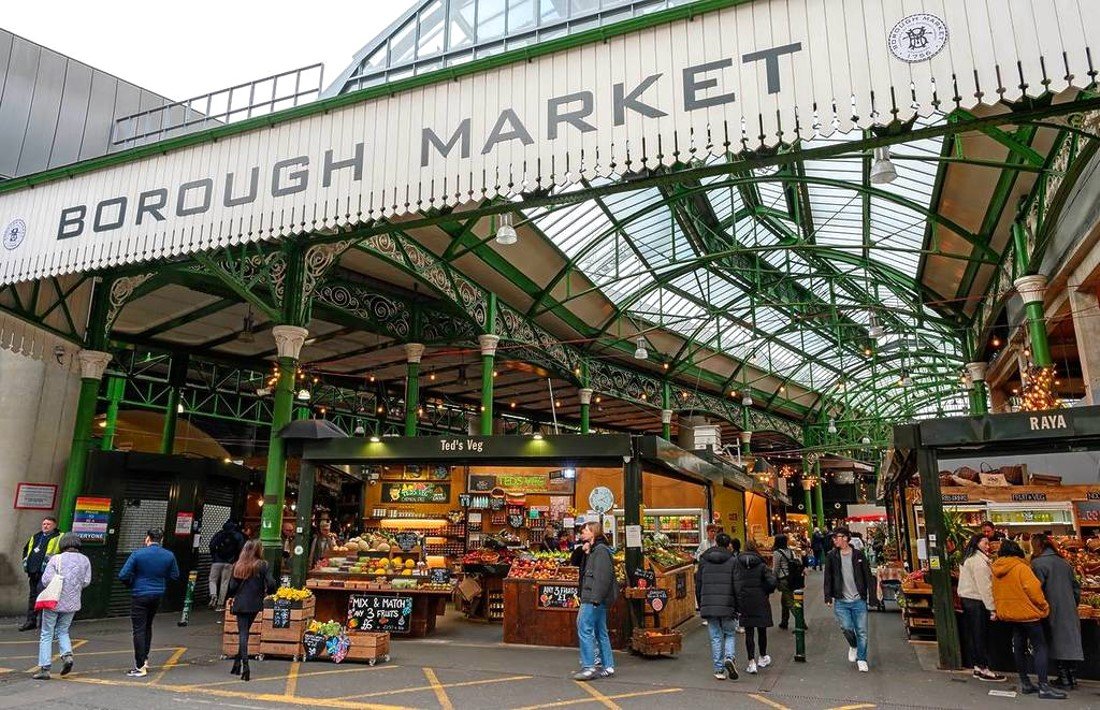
[119,527,179,678]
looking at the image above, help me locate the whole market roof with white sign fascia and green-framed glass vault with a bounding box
[0,0,1100,439]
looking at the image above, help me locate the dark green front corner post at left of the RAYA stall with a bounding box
[916,448,963,670]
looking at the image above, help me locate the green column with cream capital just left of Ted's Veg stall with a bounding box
[260,326,309,571]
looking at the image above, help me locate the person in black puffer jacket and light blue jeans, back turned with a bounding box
[695,533,737,680]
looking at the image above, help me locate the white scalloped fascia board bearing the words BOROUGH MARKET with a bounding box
[0,0,1100,284]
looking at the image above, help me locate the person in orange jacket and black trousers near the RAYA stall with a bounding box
[993,539,1066,700]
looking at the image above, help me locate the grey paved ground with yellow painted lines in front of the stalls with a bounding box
[0,575,1100,710]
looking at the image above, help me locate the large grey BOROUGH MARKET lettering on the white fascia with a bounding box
[49,42,802,241]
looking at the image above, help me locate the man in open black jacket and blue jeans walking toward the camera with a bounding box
[824,527,873,673]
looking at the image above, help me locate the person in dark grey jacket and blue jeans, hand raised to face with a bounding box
[573,522,618,680]
